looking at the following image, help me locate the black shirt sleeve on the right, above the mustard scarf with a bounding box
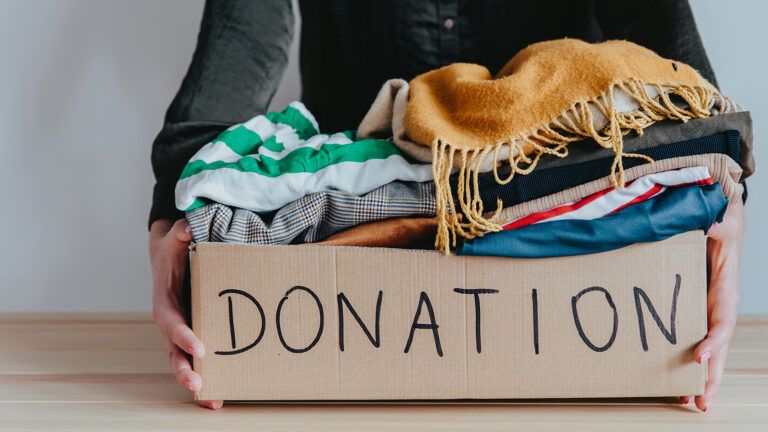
[595,0,717,87]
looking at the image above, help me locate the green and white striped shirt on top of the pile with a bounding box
[176,102,432,212]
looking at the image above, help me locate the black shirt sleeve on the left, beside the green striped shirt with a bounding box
[149,0,294,226]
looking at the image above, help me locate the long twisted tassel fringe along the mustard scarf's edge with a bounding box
[432,79,732,253]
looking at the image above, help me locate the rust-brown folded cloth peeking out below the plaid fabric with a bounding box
[313,217,437,249]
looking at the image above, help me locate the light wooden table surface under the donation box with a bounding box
[0,315,768,432]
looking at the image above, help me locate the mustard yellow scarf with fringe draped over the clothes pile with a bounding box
[403,39,722,251]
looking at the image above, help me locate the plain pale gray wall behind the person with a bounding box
[0,0,768,314]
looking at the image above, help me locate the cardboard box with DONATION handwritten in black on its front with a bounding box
[191,231,707,401]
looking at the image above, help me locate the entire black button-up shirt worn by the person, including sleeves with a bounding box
[149,0,716,228]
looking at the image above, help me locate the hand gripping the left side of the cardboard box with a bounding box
[149,219,224,409]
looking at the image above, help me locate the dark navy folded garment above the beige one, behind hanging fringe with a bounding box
[451,130,741,209]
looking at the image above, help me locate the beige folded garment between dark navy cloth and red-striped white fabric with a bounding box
[497,153,744,225]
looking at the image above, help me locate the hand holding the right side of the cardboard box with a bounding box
[681,200,744,411]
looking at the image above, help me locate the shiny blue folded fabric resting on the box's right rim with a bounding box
[456,183,728,258]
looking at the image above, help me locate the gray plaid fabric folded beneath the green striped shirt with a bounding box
[187,182,437,245]
